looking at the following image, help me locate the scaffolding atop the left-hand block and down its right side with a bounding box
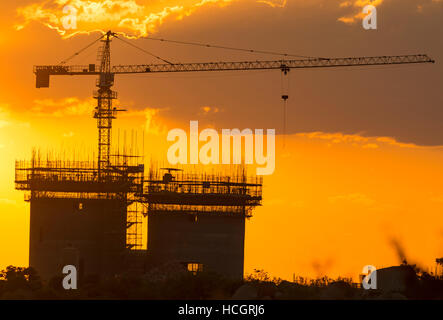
[15,153,144,250]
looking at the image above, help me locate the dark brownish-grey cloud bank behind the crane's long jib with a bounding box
[3,0,443,145]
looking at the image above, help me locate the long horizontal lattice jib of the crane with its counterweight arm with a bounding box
[34,54,435,88]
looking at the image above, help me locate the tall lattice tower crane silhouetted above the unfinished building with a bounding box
[34,31,435,181]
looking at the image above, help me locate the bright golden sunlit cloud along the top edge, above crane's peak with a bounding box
[15,0,286,38]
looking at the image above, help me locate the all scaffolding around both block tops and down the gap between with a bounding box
[15,153,263,250]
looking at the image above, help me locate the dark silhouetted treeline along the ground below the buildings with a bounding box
[0,266,443,300]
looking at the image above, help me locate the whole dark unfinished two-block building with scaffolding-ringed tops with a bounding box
[16,155,261,279]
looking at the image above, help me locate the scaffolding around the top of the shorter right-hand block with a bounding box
[141,168,263,217]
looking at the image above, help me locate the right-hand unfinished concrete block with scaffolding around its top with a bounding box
[141,170,262,278]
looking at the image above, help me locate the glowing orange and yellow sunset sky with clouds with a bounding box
[0,0,443,279]
